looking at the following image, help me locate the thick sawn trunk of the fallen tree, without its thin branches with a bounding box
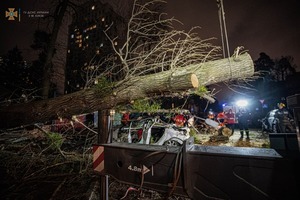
[0,53,254,128]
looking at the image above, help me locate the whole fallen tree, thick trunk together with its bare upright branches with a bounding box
[0,0,254,128]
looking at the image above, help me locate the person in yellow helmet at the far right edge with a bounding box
[273,103,295,133]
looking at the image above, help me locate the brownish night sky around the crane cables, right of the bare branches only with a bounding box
[168,0,300,68]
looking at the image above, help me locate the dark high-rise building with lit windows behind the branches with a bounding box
[65,0,126,93]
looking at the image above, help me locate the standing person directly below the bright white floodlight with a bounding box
[237,107,250,140]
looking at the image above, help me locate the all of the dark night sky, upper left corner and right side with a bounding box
[0,0,300,68]
